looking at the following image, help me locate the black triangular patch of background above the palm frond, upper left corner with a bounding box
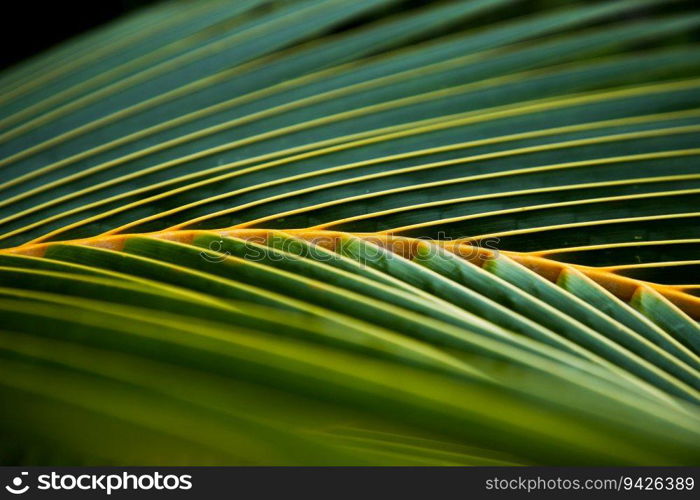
[0,0,162,70]
